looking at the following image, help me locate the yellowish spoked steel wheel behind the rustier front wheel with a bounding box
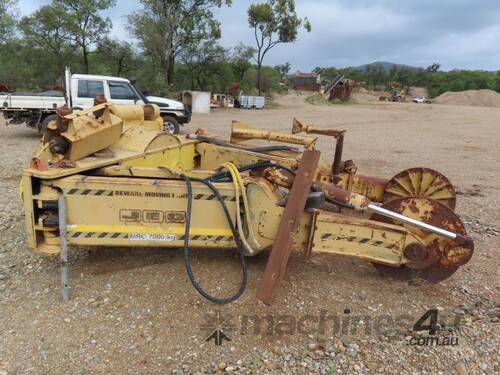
[383,168,456,210]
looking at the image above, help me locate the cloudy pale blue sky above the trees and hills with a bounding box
[19,0,500,71]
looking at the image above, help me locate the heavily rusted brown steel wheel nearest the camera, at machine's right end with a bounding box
[371,197,474,283]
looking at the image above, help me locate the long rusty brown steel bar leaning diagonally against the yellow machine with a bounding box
[257,150,320,305]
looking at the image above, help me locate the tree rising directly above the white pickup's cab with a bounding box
[54,0,116,74]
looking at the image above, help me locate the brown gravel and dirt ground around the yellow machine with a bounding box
[0,94,500,375]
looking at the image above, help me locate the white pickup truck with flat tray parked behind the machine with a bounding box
[0,69,191,134]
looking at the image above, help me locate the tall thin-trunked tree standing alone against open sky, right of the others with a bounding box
[247,0,311,95]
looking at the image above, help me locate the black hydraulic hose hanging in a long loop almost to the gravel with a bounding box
[180,173,248,304]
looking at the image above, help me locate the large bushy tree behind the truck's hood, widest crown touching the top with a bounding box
[128,0,231,86]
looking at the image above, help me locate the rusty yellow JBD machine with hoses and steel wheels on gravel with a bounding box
[21,103,473,303]
